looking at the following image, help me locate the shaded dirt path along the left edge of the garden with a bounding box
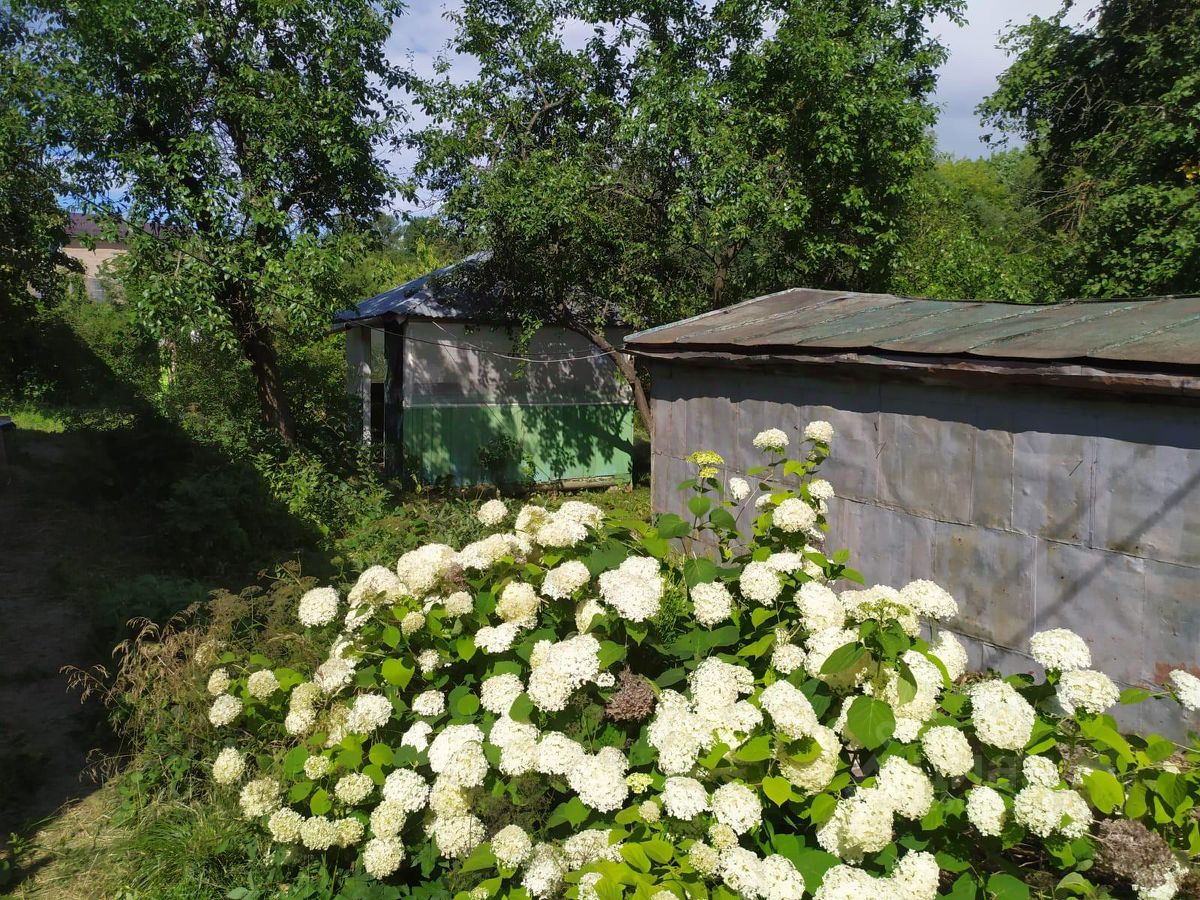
[0,432,139,844]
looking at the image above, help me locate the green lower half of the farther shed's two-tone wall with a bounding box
[402,403,634,485]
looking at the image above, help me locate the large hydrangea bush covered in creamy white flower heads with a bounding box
[201,422,1200,900]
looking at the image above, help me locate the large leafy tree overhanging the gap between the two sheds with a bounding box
[414,0,961,432]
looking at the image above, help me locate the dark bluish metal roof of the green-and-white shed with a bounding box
[334,250,493,326]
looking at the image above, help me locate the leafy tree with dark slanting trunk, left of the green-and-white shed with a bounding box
[19,0,402,444]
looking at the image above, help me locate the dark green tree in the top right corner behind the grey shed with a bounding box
[980,0,1200,296]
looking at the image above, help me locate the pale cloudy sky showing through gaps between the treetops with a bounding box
[388,0,1087,206]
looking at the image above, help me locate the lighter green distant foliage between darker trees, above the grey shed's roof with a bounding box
[890,150,1058,301]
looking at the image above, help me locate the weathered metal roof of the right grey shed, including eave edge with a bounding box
[625,288,1200,394]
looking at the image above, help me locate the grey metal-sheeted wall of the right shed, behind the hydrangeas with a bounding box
[650,362,1200,734]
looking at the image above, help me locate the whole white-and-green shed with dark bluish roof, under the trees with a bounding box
[335,254,634,485]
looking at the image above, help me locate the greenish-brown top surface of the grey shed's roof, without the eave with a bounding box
[625,288,1200,370]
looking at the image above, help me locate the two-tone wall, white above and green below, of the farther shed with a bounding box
[398,322,634,484]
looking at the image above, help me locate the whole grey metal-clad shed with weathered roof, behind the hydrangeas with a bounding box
[625,289,1200,733]
